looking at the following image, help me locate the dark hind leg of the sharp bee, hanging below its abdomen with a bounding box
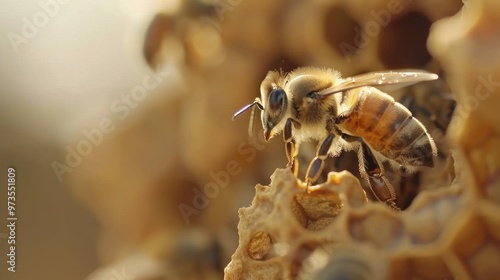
[342,134,400,210]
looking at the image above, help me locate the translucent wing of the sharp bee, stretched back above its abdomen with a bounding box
[318,70,438,97]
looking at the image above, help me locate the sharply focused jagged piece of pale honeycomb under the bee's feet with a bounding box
[225,169,368,279]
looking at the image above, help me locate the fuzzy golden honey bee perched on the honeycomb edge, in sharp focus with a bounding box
[233,67,438,209]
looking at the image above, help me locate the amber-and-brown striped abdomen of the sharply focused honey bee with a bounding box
[342,87,437,167]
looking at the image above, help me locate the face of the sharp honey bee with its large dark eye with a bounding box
[261,87,288,141]
